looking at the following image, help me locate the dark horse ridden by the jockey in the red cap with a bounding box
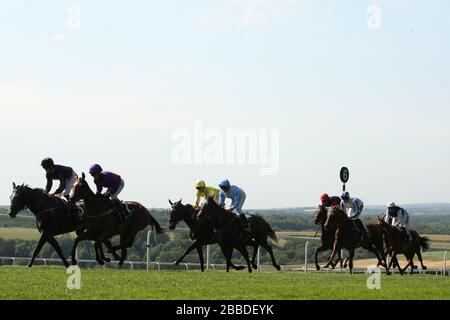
[314,206,343,271]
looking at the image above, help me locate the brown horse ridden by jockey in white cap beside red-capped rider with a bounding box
[325,207,389,274]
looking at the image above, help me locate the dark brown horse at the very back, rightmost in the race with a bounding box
[378,217,430,275]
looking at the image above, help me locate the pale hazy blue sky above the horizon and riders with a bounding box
[0,0,450,208]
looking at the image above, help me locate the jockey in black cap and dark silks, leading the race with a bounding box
[41,158,78,200]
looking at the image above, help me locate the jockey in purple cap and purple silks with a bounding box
[89,164,125,206]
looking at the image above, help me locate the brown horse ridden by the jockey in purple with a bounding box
[70,173,162,268]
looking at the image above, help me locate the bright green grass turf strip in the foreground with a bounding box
[0,267,450,300]
